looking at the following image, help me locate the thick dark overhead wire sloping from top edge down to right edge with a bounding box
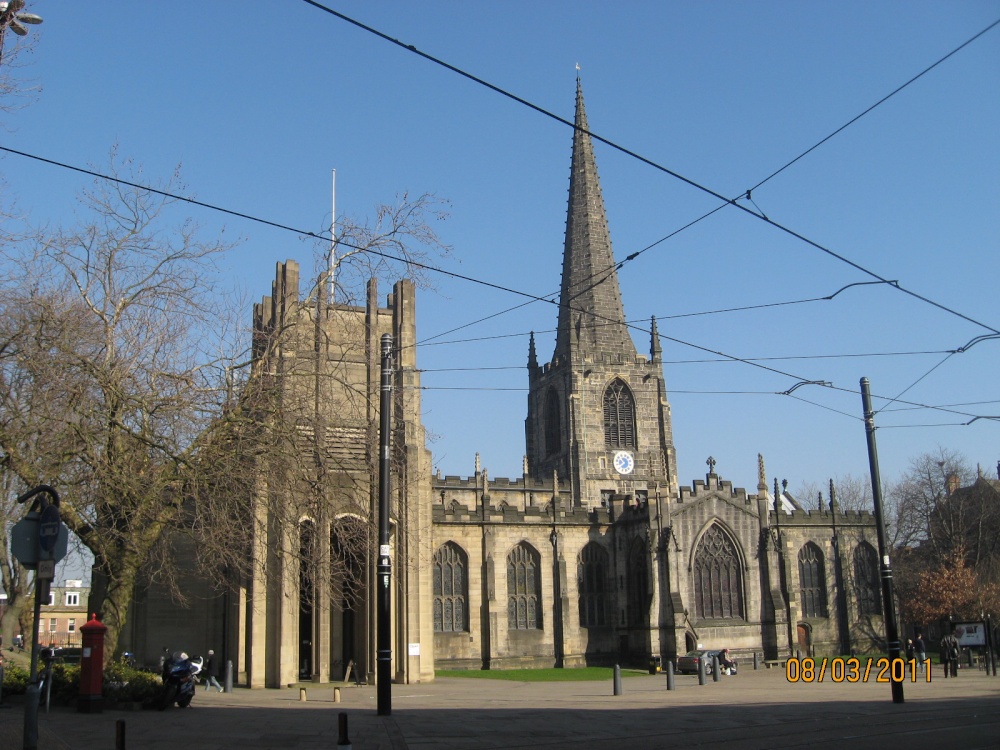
[303,0,1000,334]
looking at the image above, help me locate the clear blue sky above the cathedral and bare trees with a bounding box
[0,0,1000,512]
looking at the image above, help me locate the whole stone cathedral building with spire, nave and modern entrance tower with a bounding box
[125,80,882,687]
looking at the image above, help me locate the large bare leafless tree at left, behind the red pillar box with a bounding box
[0,157,240,655]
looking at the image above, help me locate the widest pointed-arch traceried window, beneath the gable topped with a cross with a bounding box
[694,524,743,619]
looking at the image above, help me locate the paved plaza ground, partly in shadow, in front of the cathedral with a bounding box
[0,669,1000,750]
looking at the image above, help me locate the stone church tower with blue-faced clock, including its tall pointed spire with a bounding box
[525,78,677,507]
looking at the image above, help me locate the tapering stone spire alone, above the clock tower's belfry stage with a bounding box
[553,76,636,360]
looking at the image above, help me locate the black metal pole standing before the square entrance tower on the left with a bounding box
[375,333,392,716]
